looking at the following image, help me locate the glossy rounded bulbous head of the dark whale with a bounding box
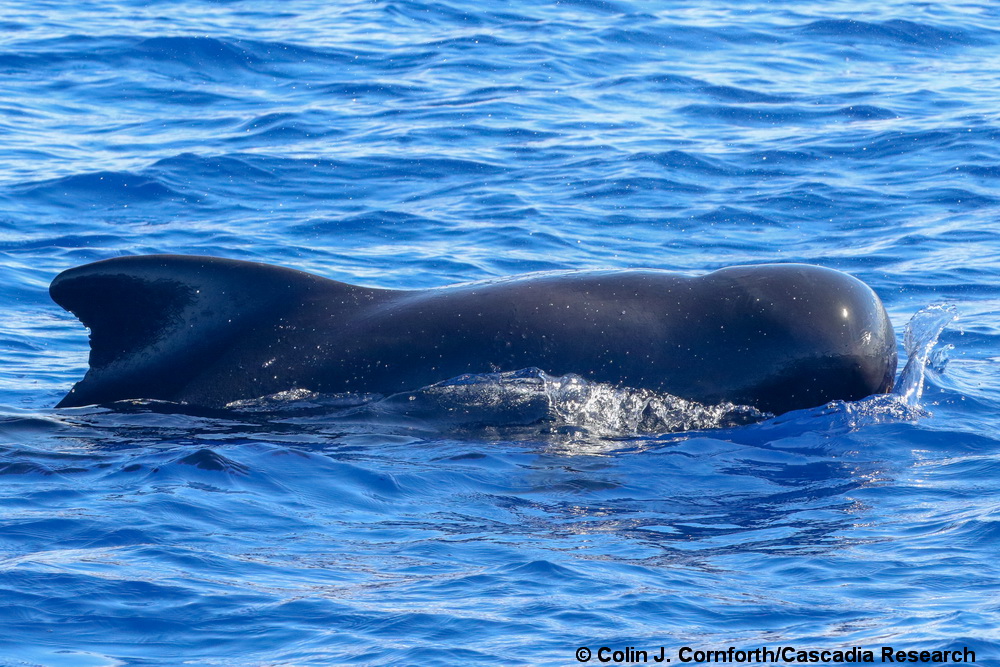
[696,264,897,414]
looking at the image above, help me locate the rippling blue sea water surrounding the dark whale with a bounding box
[0,0,1000,667]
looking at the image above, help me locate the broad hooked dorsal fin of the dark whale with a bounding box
[49,255,382,407]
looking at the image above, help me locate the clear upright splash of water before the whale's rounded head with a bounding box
[893,304,958,408]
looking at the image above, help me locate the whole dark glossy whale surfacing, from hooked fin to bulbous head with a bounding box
[50,255,896,414]
